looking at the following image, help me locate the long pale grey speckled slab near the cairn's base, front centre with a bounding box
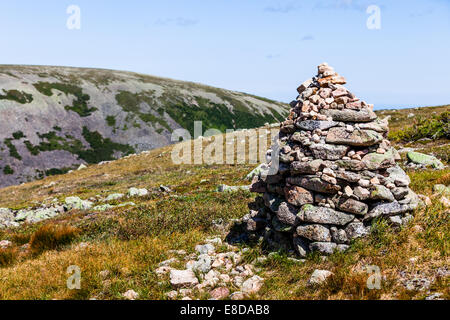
[298,204,355,226]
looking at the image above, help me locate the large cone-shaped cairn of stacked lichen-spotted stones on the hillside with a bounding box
[243,63,420,257]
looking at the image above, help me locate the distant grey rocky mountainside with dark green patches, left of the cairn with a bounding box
[0,66,289,187]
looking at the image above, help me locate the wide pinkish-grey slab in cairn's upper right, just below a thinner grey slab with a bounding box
[326,128,383,147]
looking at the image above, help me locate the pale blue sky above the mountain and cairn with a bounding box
[0,0,450,108]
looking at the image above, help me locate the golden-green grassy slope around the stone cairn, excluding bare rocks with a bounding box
[0,107,450,299]
